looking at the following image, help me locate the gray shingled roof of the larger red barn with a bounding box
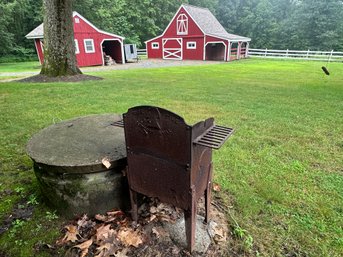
[182,4,251,41]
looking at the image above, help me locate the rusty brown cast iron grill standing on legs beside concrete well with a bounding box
[113,106,233,252]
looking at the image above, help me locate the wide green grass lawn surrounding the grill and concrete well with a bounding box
[0,59,343,257]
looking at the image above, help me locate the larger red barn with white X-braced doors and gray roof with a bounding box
[145,4,251,61]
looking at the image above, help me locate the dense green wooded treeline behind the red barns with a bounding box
[0,0,343,60]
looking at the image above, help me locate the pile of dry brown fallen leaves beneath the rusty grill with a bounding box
[49,194,228,257]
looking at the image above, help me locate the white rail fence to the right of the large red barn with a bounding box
[248,49,343,62]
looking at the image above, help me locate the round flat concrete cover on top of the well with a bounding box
[27,114,126,173]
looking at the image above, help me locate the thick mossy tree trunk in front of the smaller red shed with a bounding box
[41,0,81,77]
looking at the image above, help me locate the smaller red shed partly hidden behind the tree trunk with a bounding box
[26,12,125,67]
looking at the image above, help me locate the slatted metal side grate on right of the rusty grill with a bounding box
[194,125,234,149]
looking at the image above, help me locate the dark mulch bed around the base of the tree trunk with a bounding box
[18,74,103,83]
